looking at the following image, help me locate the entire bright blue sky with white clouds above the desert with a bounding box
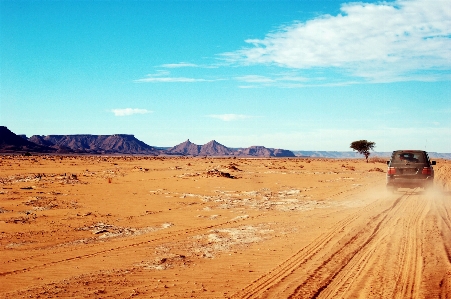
[0,0,451,153]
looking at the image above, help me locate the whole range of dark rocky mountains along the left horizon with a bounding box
[0,126,295,157]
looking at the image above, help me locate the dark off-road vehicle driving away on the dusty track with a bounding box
[387,150,436,191]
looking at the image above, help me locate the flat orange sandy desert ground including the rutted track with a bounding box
[0,156,451,298]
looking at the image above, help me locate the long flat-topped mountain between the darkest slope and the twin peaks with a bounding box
[29,134,161,155]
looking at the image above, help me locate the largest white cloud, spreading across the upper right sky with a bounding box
[223,0,451,82]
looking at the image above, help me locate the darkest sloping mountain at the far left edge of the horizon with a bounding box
[0,126,56,153]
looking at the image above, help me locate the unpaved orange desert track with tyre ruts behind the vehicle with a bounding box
[233,190,451,298]
